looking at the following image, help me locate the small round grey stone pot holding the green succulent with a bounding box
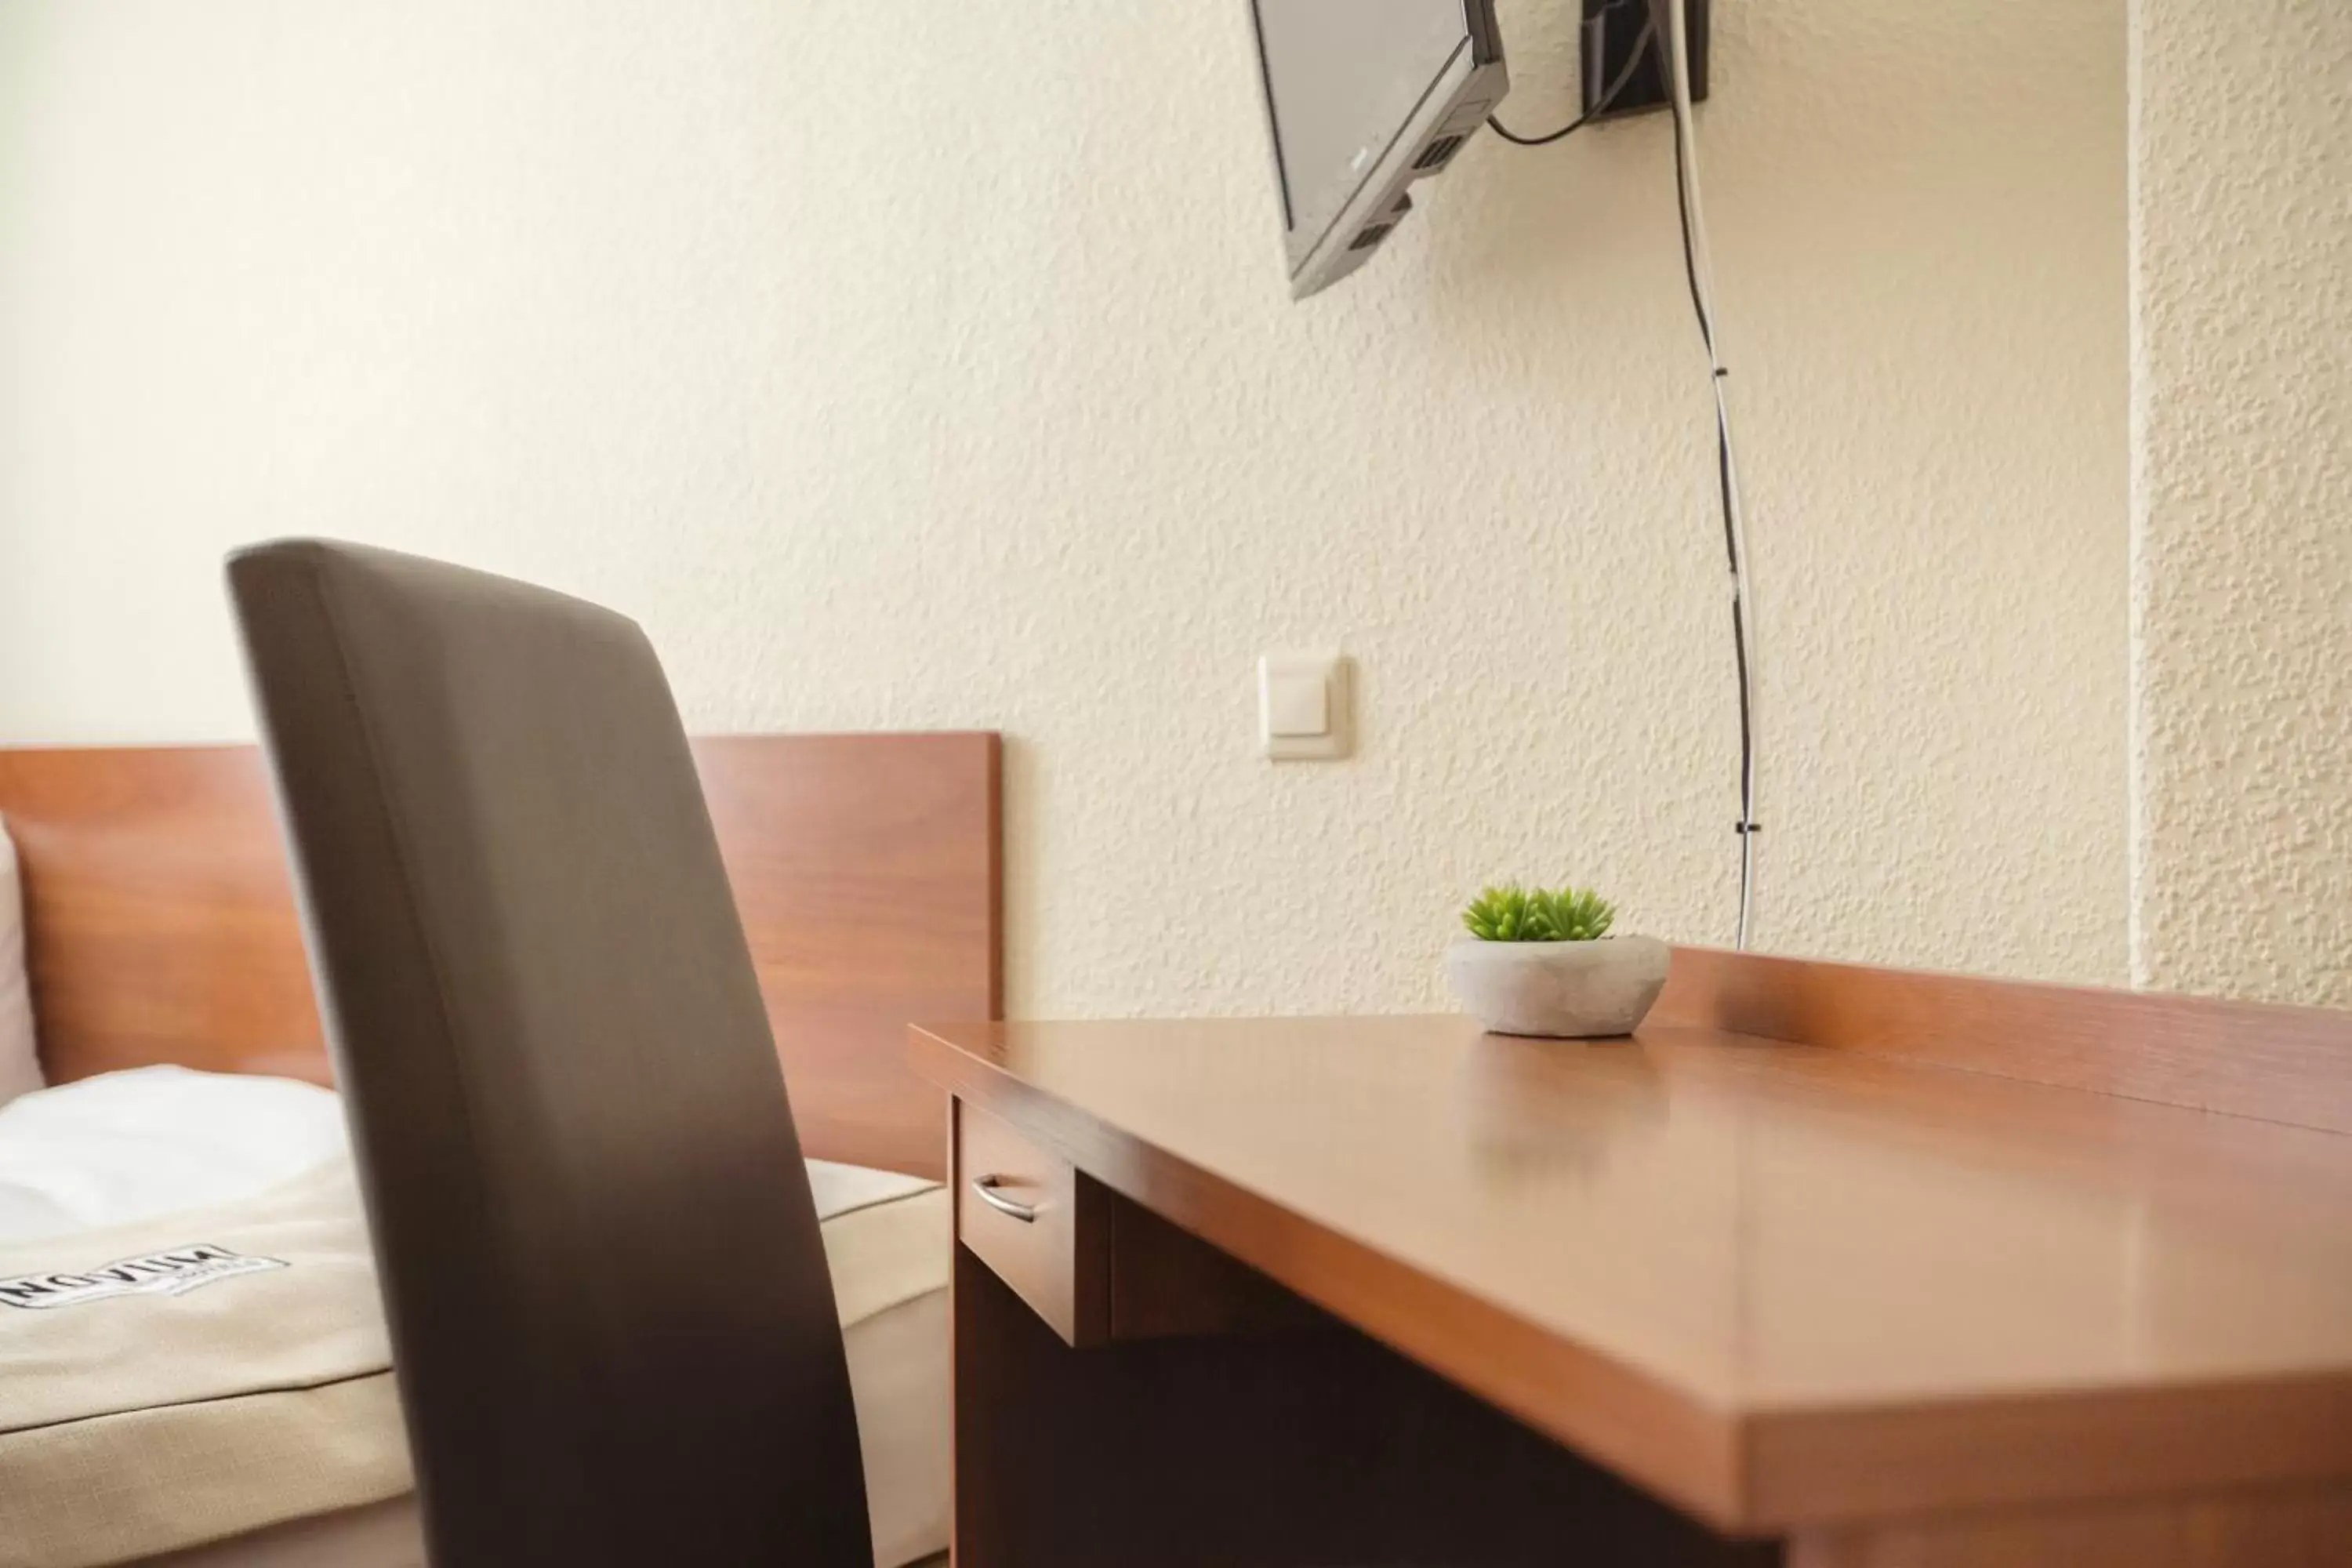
[1446,935,1668,1039]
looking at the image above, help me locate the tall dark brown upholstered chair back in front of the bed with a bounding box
[228,541,873,1568]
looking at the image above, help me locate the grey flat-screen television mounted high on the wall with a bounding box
[1251,0,1510,299]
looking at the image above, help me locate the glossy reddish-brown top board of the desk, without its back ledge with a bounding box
[915,1001,2352,1528]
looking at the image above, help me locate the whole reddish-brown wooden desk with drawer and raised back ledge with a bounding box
[913,952,2352,1568]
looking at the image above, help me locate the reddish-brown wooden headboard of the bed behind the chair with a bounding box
[0,734,1004,1175]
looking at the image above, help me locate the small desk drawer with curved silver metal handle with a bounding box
[955,1100,1110,1345]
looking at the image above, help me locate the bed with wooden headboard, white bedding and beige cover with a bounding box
[0,734,1002,1568]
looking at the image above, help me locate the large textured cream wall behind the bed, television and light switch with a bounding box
[0,0,2129,1013]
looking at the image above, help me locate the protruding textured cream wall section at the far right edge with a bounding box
[2131,0,2352,1006]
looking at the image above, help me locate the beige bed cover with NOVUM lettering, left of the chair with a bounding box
[0,1163,412,1568]
